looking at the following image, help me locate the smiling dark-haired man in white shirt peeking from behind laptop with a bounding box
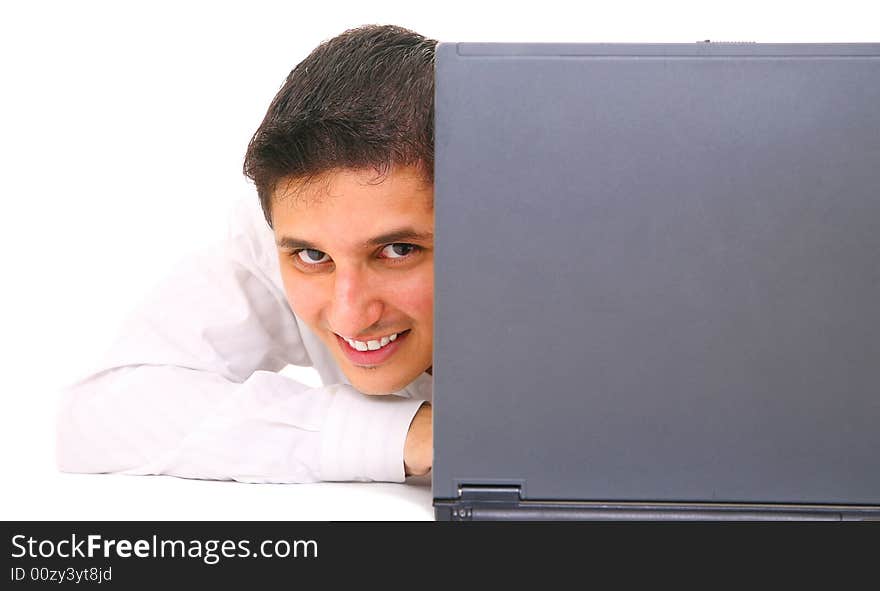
[57,26,436,483]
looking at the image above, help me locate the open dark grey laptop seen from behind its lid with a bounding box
[432,42,880,520]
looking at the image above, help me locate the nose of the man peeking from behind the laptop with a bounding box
[328,265,383,338]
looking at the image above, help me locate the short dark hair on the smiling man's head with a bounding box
[244,25,437,226]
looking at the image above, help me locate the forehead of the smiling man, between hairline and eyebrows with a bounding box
[272,167,434,245]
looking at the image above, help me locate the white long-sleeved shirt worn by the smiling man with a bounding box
[57,198,432,483]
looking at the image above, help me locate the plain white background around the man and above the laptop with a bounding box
[0,0,880,520]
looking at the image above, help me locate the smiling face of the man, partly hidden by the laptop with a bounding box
[272,167,434,394]
